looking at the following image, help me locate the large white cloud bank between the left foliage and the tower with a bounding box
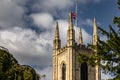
[0,27,52,65]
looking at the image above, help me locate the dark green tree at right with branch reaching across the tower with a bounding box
[78,0,120,80]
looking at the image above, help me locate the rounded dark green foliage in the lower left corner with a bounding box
[0,50,39,80]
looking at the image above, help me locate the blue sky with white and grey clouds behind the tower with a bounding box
[0,0,120,80]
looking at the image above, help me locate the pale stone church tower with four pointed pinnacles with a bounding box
[53,13,101,80]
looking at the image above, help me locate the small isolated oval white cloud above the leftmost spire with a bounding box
[31,13,54,29]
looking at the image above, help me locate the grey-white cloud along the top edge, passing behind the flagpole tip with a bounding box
[32,0,101,12]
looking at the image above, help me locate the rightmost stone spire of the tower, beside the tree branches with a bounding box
[93,18,98,45]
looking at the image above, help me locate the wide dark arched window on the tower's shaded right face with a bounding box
[81,63,88,80]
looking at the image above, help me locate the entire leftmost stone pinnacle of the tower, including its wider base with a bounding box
[53,22,61,49]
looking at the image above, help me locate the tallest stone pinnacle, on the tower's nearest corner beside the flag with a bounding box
[67,12,75,46]
